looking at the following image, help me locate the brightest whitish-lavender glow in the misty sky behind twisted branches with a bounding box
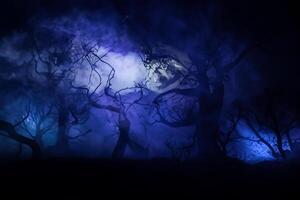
[75,47,147,92]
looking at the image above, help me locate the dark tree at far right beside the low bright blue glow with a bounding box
[243,91,298,159]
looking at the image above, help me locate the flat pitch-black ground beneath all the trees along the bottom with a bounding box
[0,159,300,199]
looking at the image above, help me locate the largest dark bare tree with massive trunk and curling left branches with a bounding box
[144,42,253,158]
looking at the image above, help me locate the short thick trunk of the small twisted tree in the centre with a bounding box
[112,118,130,159]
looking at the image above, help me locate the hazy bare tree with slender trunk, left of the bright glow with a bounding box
[30,29,92,152]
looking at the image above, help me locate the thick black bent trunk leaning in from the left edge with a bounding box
[0,120,41,159]
